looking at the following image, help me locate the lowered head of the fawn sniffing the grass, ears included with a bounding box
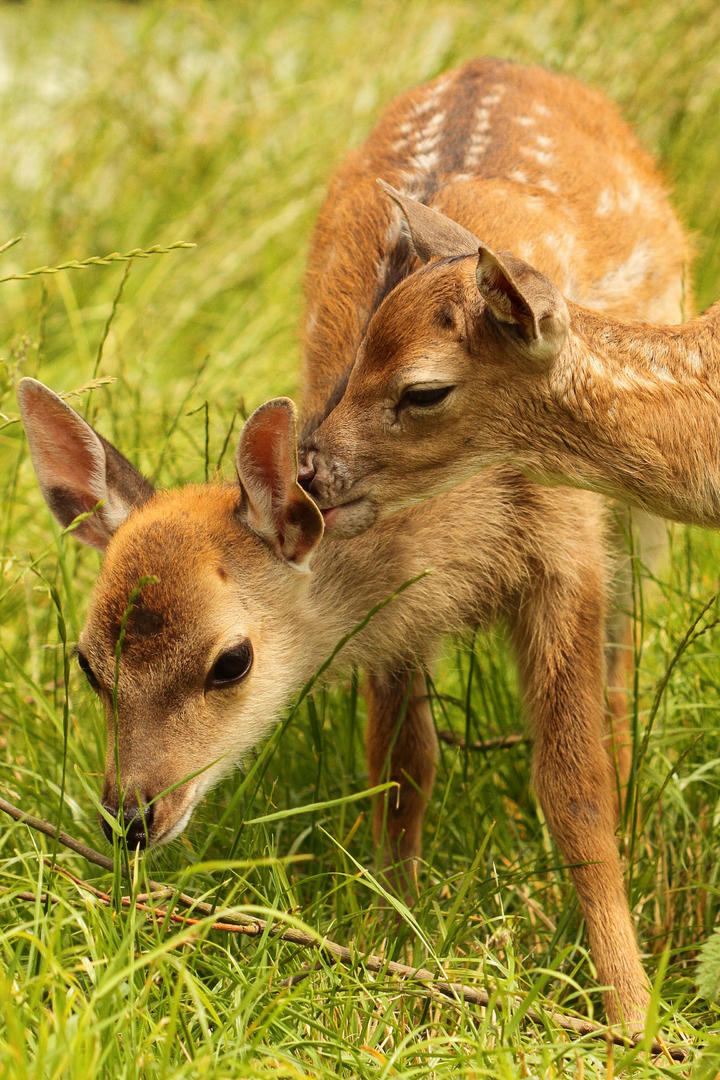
[18,379,323,845]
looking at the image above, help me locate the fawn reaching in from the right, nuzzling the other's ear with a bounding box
[303,181,720,527]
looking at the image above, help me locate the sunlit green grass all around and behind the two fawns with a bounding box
[0,0,720,1080]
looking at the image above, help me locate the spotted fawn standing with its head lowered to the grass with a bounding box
[19,59,685,1025]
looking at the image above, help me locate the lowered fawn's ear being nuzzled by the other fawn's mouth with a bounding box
[235,397,325,570]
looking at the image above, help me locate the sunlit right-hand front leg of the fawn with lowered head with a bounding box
[515,576,649,1027]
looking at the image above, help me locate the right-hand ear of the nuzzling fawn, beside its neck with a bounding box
[476,244,570,372]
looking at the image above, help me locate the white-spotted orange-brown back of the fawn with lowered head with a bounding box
[302,58,688,432]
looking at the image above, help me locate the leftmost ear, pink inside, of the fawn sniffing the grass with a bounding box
[17,379,152,551]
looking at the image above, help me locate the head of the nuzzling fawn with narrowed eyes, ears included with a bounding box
[302,184,570,536]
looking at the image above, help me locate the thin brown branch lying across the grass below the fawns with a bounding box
[0,798,684,1056]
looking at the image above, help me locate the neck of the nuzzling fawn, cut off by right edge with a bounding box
[520,302,720,526]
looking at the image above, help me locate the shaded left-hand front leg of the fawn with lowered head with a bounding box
[366,671,437,881]
